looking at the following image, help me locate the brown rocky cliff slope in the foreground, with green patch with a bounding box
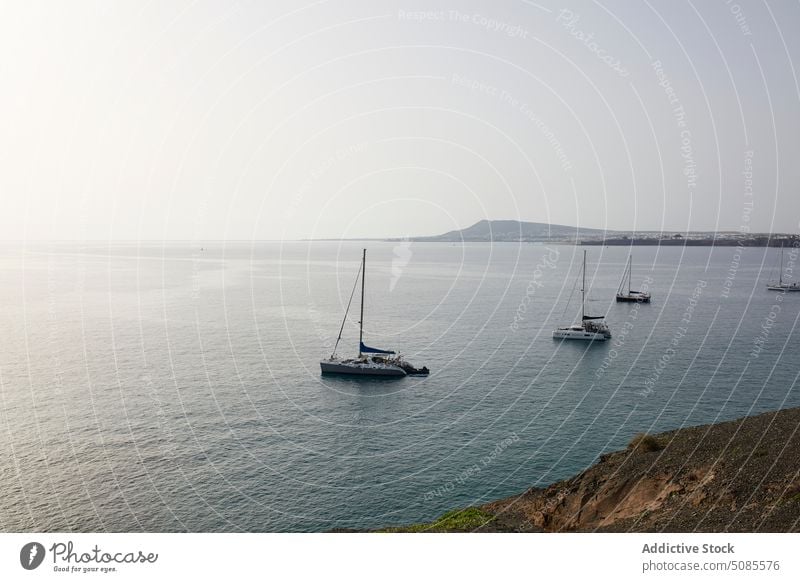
[380,408,800,532]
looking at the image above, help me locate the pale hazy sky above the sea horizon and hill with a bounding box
[0,0,800,240]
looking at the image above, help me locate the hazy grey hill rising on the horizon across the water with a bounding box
[411,220,613,242]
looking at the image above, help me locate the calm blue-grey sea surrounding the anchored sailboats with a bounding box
[0,242,800,532]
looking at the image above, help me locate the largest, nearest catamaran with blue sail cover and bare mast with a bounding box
[319,249,429,376]
